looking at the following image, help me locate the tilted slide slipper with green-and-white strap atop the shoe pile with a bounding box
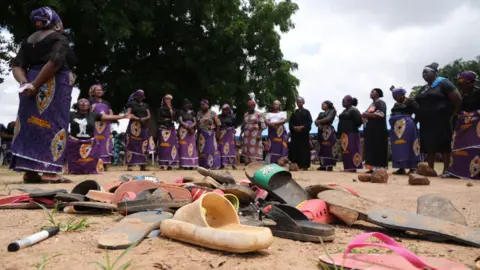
[249,164,308,206]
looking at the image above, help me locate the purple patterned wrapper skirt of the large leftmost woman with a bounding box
[10,66,73,174]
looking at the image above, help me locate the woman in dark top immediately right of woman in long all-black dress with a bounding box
[315,100,337,171]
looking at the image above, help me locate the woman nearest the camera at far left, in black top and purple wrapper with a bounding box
[10,7,75,183]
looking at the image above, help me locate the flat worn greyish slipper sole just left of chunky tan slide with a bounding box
[98,210,173,249]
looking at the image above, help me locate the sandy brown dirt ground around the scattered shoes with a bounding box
[0,167,480,270]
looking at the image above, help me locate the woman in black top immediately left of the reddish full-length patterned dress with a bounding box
[218,104,237,169]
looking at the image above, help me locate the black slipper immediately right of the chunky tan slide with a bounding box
[255,200,335,242]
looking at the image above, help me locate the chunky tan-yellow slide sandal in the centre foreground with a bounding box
[160,192,273,253]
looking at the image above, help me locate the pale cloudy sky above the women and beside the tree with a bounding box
[0,0,480,131]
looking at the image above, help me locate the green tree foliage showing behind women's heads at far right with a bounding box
[410,56,480,98]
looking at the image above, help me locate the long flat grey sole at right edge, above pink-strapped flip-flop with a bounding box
[368,209,480,247]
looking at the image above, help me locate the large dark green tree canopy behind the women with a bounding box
[0,0,299,117]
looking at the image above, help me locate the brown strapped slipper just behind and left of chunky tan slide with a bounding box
[118,188,190,214]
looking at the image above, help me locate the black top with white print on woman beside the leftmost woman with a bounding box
[70,112,102,140]
